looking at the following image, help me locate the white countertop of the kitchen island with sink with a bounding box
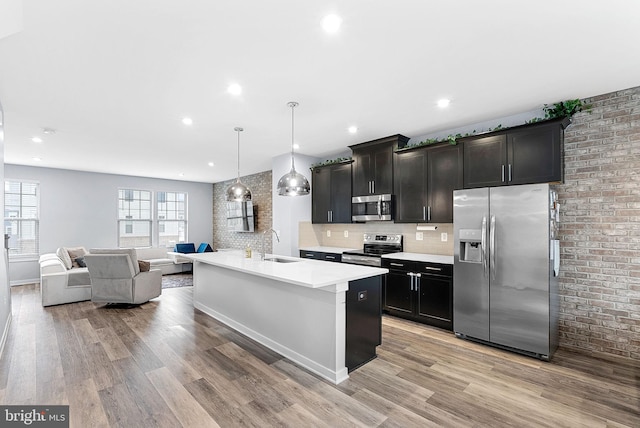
[185,250,389,288]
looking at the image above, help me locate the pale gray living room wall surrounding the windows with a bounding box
[3,165,213,285]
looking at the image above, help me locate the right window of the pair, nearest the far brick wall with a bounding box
[156,192,187,247]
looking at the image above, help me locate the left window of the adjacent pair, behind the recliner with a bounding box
[118,189,153,248]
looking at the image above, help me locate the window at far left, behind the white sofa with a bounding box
[4,180,40,257]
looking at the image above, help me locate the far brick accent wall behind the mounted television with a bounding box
[213,171,273,253]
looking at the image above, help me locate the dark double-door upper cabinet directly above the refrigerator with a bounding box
[460,118,569,189]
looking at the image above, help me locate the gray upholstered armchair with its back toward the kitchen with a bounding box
[84,248,162,304]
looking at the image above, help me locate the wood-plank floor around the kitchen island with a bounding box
[0,285,640,427]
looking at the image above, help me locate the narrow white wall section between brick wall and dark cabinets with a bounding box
[271,153,318,257]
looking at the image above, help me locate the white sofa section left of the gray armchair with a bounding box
[40,253,91,306]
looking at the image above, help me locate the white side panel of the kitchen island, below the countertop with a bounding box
[193,262,348,384]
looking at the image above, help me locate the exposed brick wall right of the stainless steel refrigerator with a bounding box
[558,87,640,359]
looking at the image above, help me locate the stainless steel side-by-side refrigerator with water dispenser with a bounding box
[453,184,559,360]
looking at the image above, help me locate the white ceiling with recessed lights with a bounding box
[0,0,640,182]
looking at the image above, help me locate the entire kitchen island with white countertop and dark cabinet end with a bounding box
[185,251,388,384]
